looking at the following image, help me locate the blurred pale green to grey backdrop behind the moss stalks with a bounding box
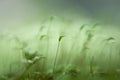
[0,0,120,80]
